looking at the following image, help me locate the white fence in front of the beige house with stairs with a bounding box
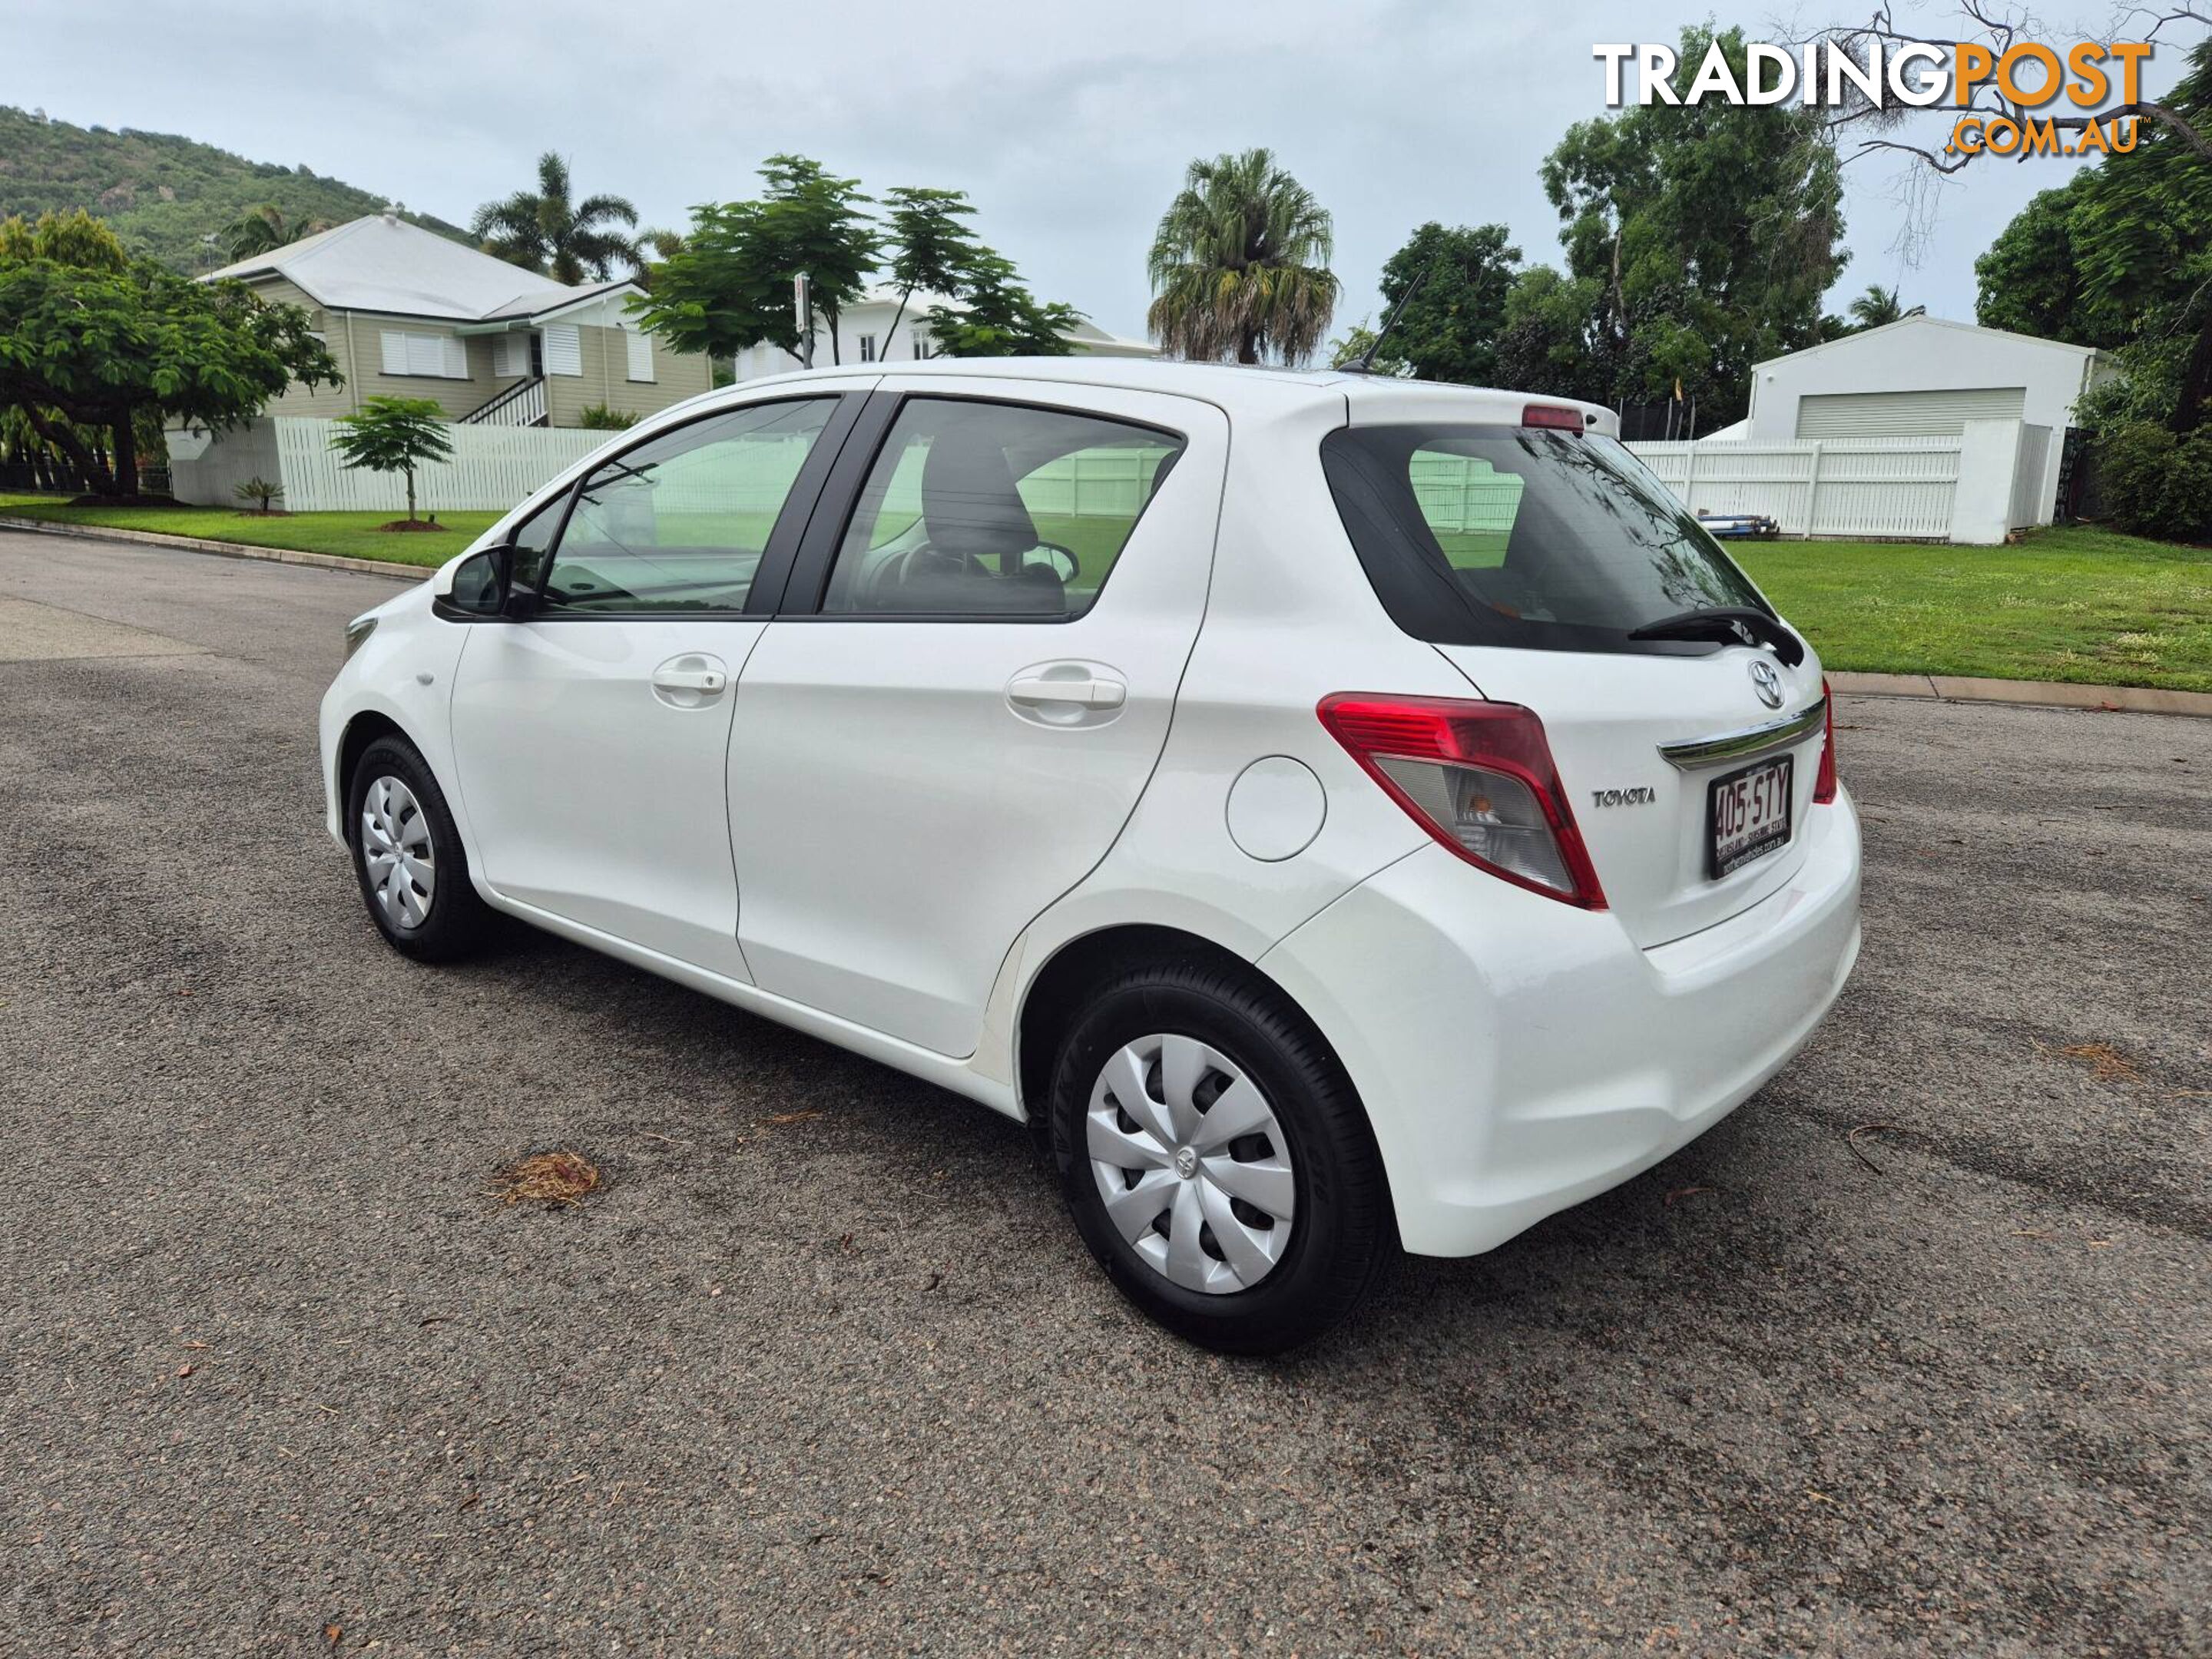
[274,416,621,513]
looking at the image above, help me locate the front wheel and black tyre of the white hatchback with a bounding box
[345,737,491,962]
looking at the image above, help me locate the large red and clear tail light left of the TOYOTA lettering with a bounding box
[1318,692,1606,909]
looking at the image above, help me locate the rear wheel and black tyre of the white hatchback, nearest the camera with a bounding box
[1051,965,1398,1354]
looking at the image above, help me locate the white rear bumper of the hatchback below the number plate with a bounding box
[1261,794,1858,1257]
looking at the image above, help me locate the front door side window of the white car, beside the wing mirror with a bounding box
[540,398,836,615]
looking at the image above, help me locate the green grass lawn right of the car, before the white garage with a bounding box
[1727,526,2212,692]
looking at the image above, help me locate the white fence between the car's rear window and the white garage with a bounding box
[1628,427,1964,542]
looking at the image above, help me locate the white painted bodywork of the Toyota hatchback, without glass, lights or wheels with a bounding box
[321,359,1858,1254]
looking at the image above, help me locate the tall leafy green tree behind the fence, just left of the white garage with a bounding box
[1522,28,1847,422]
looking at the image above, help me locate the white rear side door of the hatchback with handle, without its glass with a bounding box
[730,374,1230,1055]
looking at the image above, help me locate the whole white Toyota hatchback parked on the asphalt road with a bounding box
[321,360,1858,1352]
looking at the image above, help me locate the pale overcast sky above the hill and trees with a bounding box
[0,0,2179,334]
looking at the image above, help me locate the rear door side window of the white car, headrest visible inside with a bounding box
[823,398,1184,619]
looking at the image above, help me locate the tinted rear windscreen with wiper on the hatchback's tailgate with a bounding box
[1320,425,1770,654]
